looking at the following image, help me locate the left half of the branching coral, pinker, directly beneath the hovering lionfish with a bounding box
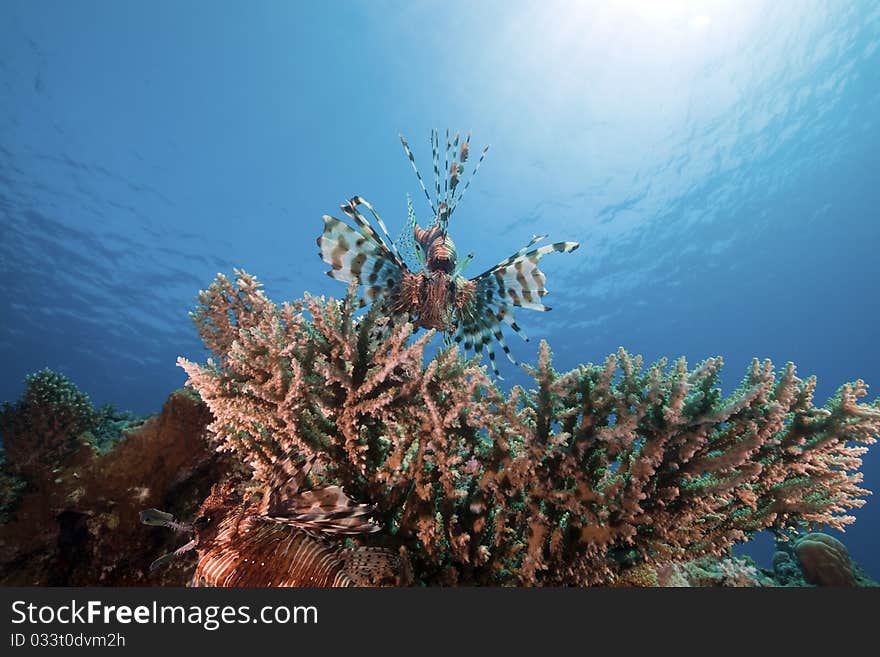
[180,272,503,577]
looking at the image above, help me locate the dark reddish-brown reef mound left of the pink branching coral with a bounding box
[0,382,230,586]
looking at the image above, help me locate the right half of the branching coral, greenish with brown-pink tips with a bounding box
[478,344,880,583]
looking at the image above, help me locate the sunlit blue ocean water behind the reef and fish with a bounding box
[0,0,880,577]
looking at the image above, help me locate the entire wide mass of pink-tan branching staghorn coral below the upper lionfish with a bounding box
[179,272,880,585]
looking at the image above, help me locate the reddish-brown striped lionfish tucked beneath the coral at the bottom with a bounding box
[141,457,405,587]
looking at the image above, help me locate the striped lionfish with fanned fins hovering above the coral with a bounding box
[318,130,579,378]
